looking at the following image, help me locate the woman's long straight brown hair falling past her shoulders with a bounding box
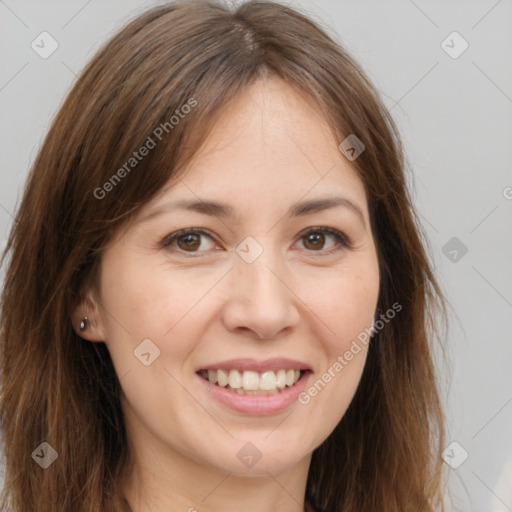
[0,0,445,512]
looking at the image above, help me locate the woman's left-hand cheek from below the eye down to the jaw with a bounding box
[97,258,211,428]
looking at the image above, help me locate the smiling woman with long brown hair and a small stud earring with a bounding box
[0,1,444,512]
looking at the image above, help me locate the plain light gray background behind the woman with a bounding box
[0,0,512,512]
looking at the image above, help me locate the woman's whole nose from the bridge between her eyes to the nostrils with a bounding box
[224,236,299,338]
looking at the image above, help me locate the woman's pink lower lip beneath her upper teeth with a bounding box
[197,371,311,416]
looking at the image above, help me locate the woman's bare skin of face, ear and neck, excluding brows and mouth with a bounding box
[74,78,379,512]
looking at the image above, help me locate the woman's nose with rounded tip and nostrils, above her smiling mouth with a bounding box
[222,250,300,339]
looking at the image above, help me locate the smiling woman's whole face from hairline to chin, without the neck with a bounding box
[81,79,379,475]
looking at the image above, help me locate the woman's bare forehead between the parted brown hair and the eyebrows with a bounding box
[158,78,365,202]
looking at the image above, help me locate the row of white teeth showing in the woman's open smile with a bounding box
[197,369,307,396]
